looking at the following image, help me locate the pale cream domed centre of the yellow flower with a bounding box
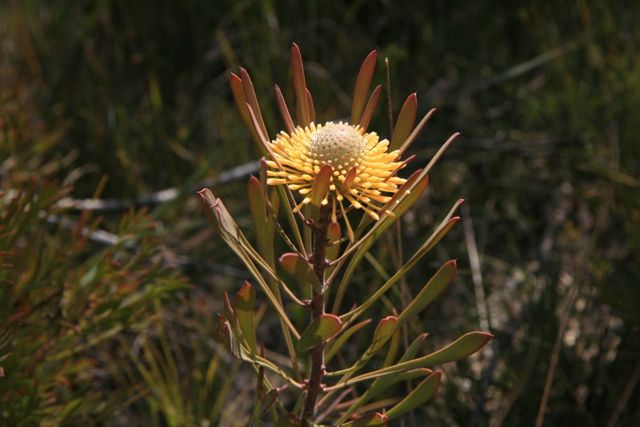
[307,122,367,171]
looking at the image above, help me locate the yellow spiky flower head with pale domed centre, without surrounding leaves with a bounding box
[266,122,405,220]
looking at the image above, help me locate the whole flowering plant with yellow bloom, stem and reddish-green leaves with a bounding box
[199,44,492,426]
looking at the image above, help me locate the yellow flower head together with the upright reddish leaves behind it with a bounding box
[230,43,424,222]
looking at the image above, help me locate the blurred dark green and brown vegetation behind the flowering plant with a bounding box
[0,0,640,426]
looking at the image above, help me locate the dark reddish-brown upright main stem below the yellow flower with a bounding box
[300,205,331,427]
